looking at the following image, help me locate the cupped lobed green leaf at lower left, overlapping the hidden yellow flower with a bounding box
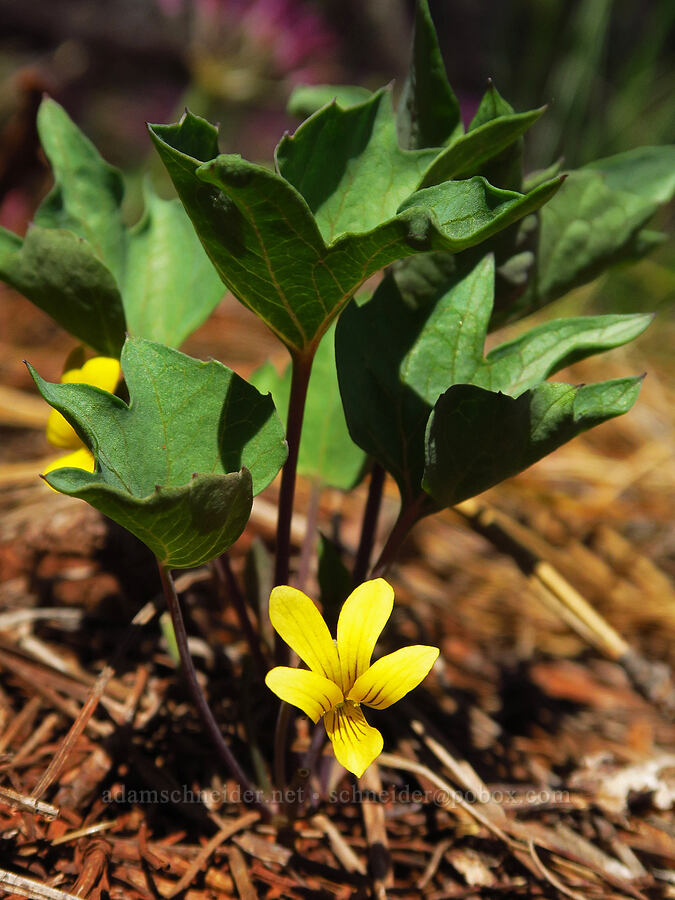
[31,338,287,568]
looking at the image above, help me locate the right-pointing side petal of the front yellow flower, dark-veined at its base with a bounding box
[348,644,439,709]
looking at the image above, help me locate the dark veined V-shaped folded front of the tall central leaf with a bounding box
[151,109,558,356]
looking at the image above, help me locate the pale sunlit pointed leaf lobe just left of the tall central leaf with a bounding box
[124,186,224,347]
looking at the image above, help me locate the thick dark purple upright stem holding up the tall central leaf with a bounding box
[274,355,314,664]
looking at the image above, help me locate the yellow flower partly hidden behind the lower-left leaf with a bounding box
[43,356,121,475]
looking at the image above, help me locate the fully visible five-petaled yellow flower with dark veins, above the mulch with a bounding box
[265,578,439,777]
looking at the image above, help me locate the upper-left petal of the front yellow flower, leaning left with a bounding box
[270,585,340,686]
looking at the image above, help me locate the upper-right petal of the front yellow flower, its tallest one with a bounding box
[337,578,394,694]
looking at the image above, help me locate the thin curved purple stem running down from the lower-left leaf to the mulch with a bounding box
[157,560,269,817]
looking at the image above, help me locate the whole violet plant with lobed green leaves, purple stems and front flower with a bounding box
[0,0,675,800]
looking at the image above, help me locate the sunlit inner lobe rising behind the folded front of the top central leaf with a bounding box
[276,88,438,243]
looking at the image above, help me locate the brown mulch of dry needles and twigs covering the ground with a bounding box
[0,284,675,900]
